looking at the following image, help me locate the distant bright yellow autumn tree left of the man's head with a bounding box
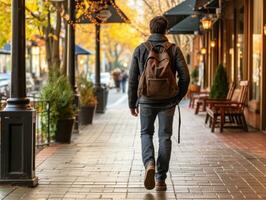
[76,0,142,71]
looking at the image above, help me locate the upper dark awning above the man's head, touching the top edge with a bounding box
[164,0,196,28]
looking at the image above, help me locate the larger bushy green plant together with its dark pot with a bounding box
[41,75,75,143]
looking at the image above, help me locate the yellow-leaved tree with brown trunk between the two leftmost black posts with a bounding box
[27,0,66,76]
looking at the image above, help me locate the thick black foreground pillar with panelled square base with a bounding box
[0,0,38,187]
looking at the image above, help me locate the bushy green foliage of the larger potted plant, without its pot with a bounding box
[41,73,75,136]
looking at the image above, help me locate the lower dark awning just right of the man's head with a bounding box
[168,16,200,34]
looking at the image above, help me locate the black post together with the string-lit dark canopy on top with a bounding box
[76,0,129,113]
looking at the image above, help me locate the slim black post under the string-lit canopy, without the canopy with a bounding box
[95,24,108,113]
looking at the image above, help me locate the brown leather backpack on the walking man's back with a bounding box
[138,41,178,100]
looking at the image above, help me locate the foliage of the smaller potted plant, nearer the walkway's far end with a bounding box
[77,76,97,106]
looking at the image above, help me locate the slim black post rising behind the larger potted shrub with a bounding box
[67,0,79,133]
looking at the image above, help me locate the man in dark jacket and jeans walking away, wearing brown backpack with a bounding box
[128,16,190,191]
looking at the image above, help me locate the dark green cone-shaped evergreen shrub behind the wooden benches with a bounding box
[210,64,228,99]
